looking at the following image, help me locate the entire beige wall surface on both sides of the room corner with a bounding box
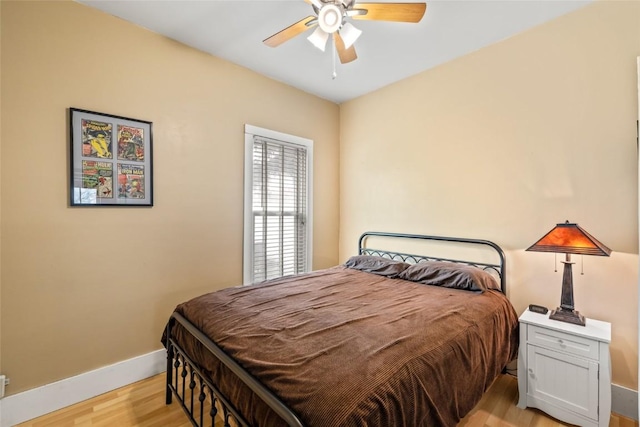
[0,1,640,400]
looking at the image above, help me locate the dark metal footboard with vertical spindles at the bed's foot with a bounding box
[165,312,303,427]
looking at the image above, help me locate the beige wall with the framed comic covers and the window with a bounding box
[0,1,339,393]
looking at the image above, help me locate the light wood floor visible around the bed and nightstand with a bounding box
[19,375,638,427]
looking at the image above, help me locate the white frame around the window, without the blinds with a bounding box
[242,124,313,285]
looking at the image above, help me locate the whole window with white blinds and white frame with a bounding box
[243,125,313,285]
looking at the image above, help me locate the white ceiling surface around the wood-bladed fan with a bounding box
[77,0,593,103]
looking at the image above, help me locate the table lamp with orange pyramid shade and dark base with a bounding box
[527,221,611,326]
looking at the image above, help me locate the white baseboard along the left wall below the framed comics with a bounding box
[0,350,167,427]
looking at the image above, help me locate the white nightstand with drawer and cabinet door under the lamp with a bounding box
[518,310,611,427]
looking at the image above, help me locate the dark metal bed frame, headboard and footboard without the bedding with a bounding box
[164,232,506,427]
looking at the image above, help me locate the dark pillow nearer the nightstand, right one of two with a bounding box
[398,261,500,292]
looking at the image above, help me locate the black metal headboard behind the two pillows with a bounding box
[358,231,507,295]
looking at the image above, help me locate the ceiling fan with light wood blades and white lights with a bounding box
[263,0,427,64]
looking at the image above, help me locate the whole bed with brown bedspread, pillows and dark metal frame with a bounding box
[162,232,518,427]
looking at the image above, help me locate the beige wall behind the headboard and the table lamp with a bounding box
[340,1,640,389]
